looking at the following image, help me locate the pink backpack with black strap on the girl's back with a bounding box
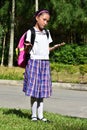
[16,28,35,68]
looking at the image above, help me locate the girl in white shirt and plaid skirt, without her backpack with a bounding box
[23,10,65,122]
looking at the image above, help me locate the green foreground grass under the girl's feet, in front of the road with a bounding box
[0,108,87,130]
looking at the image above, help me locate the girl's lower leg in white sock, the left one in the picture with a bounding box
[31,97,37,118]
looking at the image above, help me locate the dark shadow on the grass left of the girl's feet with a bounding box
[3,109,31,119]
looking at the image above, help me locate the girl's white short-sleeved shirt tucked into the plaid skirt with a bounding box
[26,27,52,60]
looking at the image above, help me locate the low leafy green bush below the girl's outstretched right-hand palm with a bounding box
[51,44,87,65]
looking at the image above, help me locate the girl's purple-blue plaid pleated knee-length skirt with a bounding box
[23,59,52,98]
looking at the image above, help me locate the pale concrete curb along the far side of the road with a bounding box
[0,80,87,91]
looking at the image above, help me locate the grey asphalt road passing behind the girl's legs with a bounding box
[0,84,87,118]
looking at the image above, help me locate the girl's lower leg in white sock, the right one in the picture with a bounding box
[37,98,43,119]
